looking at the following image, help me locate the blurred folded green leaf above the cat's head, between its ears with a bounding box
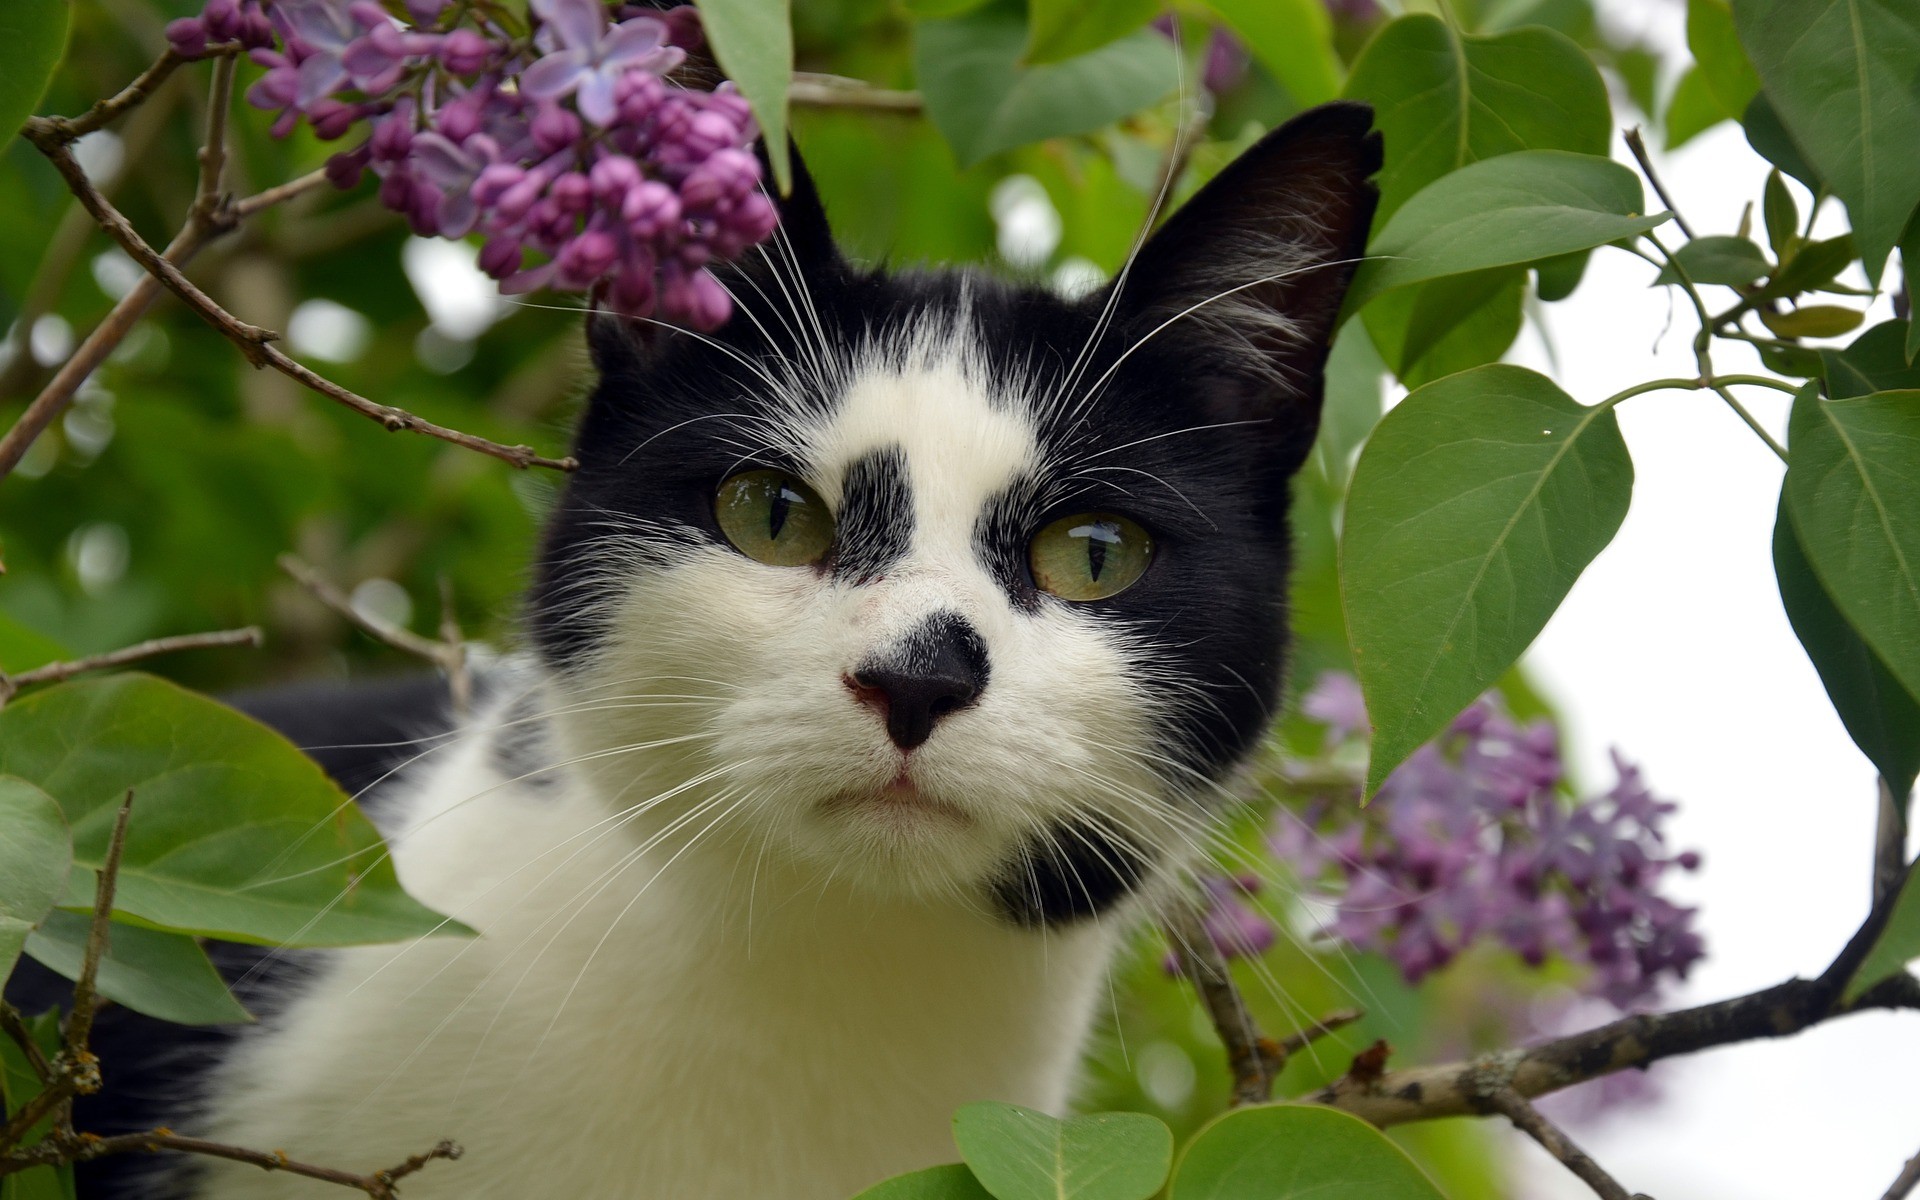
[914,6,1179,167]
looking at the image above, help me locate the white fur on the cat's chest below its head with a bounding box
[194,702,1112,1200]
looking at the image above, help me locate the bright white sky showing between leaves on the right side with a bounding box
[1509,0,1920,1200]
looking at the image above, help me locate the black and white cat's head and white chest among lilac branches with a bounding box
[37,104,1380,1200]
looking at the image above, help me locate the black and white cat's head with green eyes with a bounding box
[534,106,1379,924]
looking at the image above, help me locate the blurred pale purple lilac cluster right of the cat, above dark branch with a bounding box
[1271,674,1705,1010]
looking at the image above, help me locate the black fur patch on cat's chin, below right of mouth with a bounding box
[993,820,1146,929]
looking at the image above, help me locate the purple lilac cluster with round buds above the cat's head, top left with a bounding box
[167,0,778,328]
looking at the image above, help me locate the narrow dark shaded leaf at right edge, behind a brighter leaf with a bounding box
[1774,488,1920,797]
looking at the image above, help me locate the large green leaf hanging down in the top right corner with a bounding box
[1734,0,1920,286]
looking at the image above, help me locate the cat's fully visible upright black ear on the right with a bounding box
[1119,102,1380,470]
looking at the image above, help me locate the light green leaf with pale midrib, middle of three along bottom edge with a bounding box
[954,1100,1173,1200]
